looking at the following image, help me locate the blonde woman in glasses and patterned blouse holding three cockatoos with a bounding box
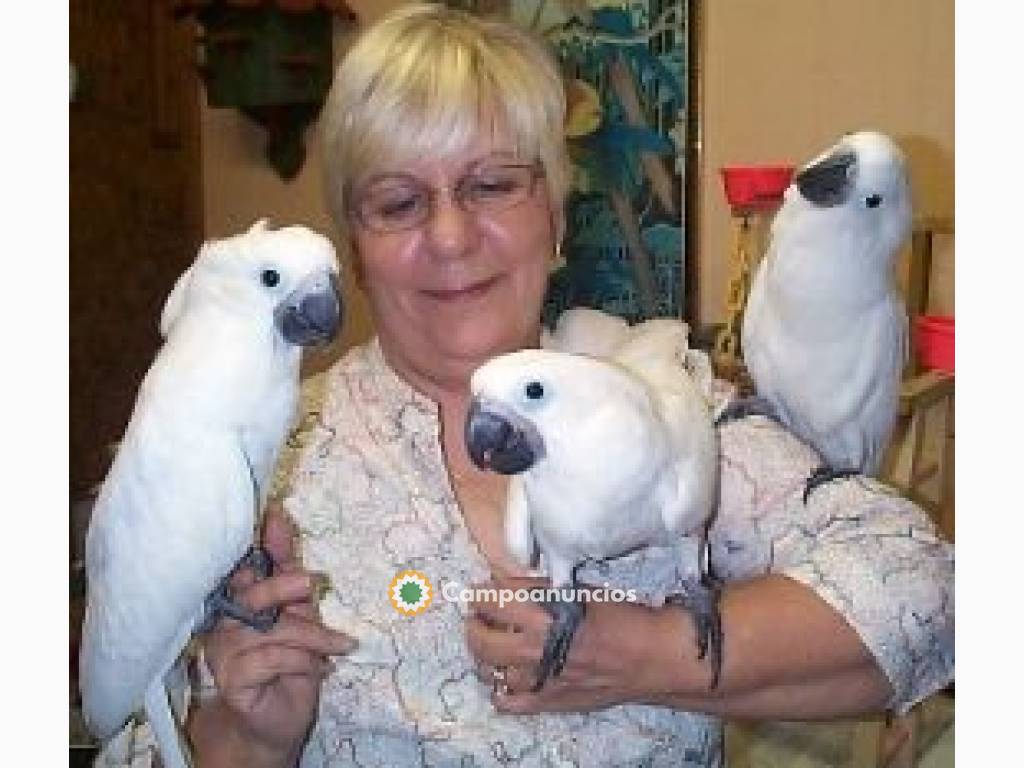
[97,5,952,766]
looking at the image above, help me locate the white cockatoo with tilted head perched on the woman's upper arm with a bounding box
[725,131,911,500]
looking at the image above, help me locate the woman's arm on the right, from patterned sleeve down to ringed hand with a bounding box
[467,420,953,719]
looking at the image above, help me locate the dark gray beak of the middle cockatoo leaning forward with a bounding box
[466,397,544,475]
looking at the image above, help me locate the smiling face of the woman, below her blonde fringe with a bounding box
[353,129,558,387]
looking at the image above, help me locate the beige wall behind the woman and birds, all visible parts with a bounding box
[197,0,953,339]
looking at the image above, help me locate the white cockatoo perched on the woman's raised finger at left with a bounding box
[80,221,342,768]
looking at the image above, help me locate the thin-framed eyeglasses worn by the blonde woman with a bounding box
[350,163,544,233]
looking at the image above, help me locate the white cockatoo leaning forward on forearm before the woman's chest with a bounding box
[466,310,721,687]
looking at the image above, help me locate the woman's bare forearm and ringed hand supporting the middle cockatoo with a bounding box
[467,575,891,720]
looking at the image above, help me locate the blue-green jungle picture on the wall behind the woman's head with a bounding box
[449,0,695,324]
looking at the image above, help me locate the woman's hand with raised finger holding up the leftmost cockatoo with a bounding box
[191,509,355,766]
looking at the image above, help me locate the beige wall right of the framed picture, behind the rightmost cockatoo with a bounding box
[698,0,953,322]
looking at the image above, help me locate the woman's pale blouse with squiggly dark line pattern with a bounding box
[97,340,953,768]
